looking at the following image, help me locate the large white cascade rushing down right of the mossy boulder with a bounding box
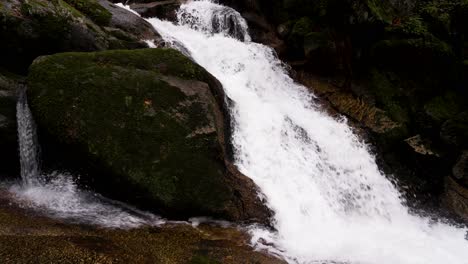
[144,0,468,264]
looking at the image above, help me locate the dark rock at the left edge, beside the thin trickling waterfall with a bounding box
[0,72,23,178]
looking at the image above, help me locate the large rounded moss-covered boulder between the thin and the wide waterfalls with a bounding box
[28,49,270,223]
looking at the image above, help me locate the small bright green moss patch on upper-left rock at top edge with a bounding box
[65,0,112,26]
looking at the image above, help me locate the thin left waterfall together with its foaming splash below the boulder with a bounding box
[9,87,163,228]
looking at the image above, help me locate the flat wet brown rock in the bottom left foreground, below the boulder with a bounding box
[0,190,285,264]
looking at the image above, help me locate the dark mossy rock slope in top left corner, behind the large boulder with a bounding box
[0,0,159,73]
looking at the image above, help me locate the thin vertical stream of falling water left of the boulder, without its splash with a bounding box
[16,86,40,186]
